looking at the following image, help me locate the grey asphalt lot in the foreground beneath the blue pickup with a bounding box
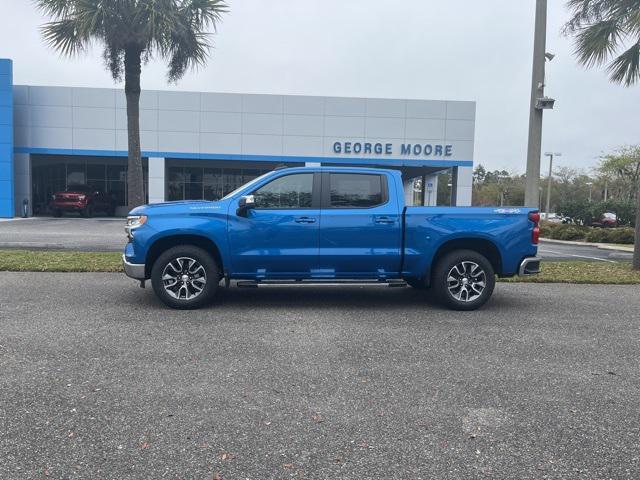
[0,272,640,480]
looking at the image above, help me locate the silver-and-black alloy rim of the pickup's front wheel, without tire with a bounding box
[162,257,207,300]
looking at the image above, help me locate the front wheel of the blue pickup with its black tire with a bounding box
[151,245,220,310]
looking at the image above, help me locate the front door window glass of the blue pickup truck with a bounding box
[253,173,313,209]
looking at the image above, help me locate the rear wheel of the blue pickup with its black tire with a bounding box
[431,250,496,310]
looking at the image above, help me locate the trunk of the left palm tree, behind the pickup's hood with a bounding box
[124,47,144,209]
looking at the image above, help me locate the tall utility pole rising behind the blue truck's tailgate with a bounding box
[524,0,547,207]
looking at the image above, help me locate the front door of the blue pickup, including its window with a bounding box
[229,173,320,279]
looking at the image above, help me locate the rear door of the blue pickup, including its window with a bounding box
[320,173,402,278]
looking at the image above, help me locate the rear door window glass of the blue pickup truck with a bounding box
[329,173,386,208]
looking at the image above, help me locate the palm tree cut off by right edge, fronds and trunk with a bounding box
[564,0,640,270]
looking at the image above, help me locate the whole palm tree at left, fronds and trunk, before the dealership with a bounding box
[36,0,227,208]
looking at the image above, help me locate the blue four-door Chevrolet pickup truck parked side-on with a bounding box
[123,167,540,310]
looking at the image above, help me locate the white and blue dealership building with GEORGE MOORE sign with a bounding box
[0,59,475,217]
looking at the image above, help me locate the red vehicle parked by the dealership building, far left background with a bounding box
[49,185,116,217]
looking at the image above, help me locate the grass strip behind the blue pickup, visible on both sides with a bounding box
[0,250,640,285]
